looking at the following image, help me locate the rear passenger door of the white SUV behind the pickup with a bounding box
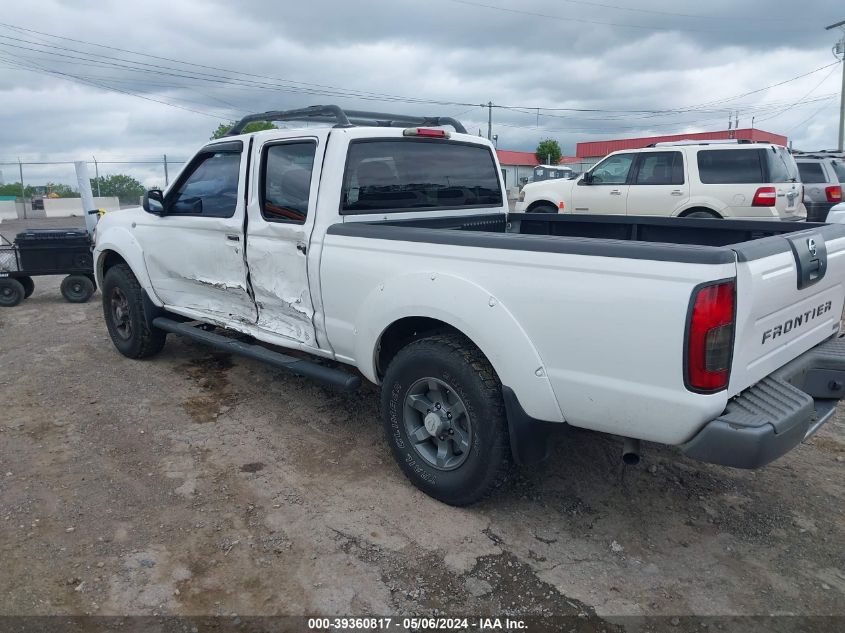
[627,151,690,216]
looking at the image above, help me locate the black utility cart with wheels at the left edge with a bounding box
[0,229,96,307]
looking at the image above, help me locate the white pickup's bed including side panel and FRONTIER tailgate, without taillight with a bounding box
[321,214,845,444]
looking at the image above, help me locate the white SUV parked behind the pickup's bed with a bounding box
[516,141,807,220]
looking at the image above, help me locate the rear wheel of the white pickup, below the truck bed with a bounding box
[381,333,511,506]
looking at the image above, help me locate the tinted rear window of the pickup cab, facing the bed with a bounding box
[341,138,503,214]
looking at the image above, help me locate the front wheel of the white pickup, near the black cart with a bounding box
[103,264,167,359]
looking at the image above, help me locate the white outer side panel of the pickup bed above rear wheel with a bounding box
[321,234,735,444]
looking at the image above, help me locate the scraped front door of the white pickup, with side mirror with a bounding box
[135,141,256,323]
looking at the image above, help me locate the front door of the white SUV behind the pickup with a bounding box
[570,154,637,215]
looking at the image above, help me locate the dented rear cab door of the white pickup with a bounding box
[246,130,329,347]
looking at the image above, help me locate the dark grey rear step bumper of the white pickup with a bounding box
[681,336,845,468]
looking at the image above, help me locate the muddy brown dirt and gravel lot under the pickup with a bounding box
[0,220,845,630]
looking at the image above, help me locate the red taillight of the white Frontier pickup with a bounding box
[686,281,736,391]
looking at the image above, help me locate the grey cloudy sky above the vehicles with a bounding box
[0,0,845,185]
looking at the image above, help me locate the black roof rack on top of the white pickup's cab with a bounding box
[226,105,466,136]
